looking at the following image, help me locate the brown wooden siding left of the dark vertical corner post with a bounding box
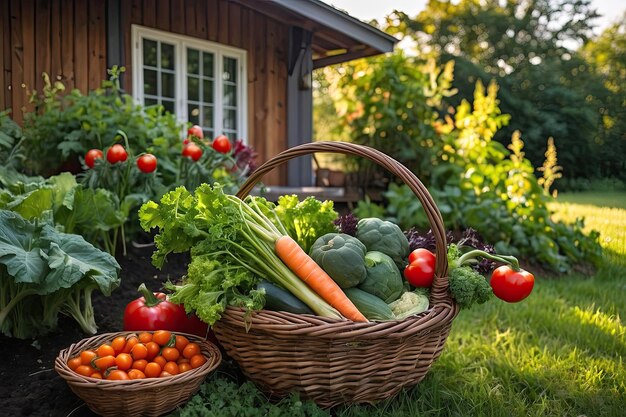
[0,0,106,123]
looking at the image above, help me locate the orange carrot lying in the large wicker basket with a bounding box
[274,235,368,322]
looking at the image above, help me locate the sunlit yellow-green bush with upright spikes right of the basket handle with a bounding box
[356,82,601,272]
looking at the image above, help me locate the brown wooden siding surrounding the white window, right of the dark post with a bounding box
[122,0,289,184]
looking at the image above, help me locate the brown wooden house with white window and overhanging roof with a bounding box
[0,0,396,186]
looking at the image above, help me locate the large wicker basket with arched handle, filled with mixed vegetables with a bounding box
[214,142,458,407]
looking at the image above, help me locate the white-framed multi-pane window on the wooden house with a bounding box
[133,27,247,139]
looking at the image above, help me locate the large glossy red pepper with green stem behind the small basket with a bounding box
[124,284,188,332]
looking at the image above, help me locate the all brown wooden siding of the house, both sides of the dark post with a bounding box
[0,0,289,184]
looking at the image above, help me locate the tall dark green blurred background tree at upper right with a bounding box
[387,0,615,177]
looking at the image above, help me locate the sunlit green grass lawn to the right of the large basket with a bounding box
[172,193,626,417]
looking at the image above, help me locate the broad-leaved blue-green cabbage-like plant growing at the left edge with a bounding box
[0,210,120,339]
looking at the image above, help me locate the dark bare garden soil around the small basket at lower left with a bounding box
[0,240,188,417]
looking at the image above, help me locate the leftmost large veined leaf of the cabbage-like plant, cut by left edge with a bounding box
[0,210,47,284]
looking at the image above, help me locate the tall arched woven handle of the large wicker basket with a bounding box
[237,142,449,303]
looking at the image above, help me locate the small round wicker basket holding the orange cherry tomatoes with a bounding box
[54,332,222,417]
